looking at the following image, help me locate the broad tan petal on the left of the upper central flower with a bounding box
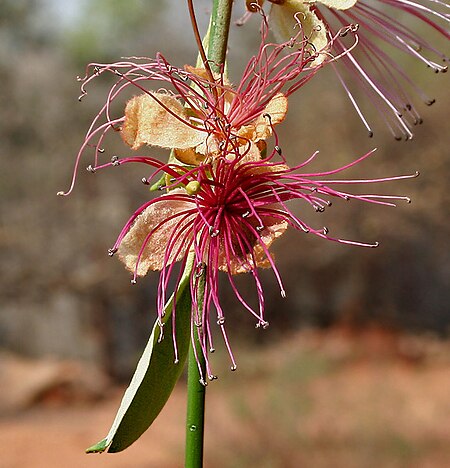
[121,93,206,150]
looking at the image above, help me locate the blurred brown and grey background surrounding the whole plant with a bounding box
[0,0,450,468]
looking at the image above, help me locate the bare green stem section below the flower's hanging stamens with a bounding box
[185,330,206,468]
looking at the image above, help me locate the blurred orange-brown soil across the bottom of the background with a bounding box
[0,328,450,468]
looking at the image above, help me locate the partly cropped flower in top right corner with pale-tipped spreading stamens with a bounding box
[251,0,450,139]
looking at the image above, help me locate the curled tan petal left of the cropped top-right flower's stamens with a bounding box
[270,0,328,66]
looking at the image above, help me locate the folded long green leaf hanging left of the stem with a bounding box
[86,256,193,453]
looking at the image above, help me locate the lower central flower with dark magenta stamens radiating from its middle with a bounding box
[89,144,414,379]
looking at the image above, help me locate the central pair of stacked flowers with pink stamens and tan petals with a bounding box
[60,11,422,378]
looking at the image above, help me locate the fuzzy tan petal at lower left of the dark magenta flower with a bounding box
[118,189,192,276]
